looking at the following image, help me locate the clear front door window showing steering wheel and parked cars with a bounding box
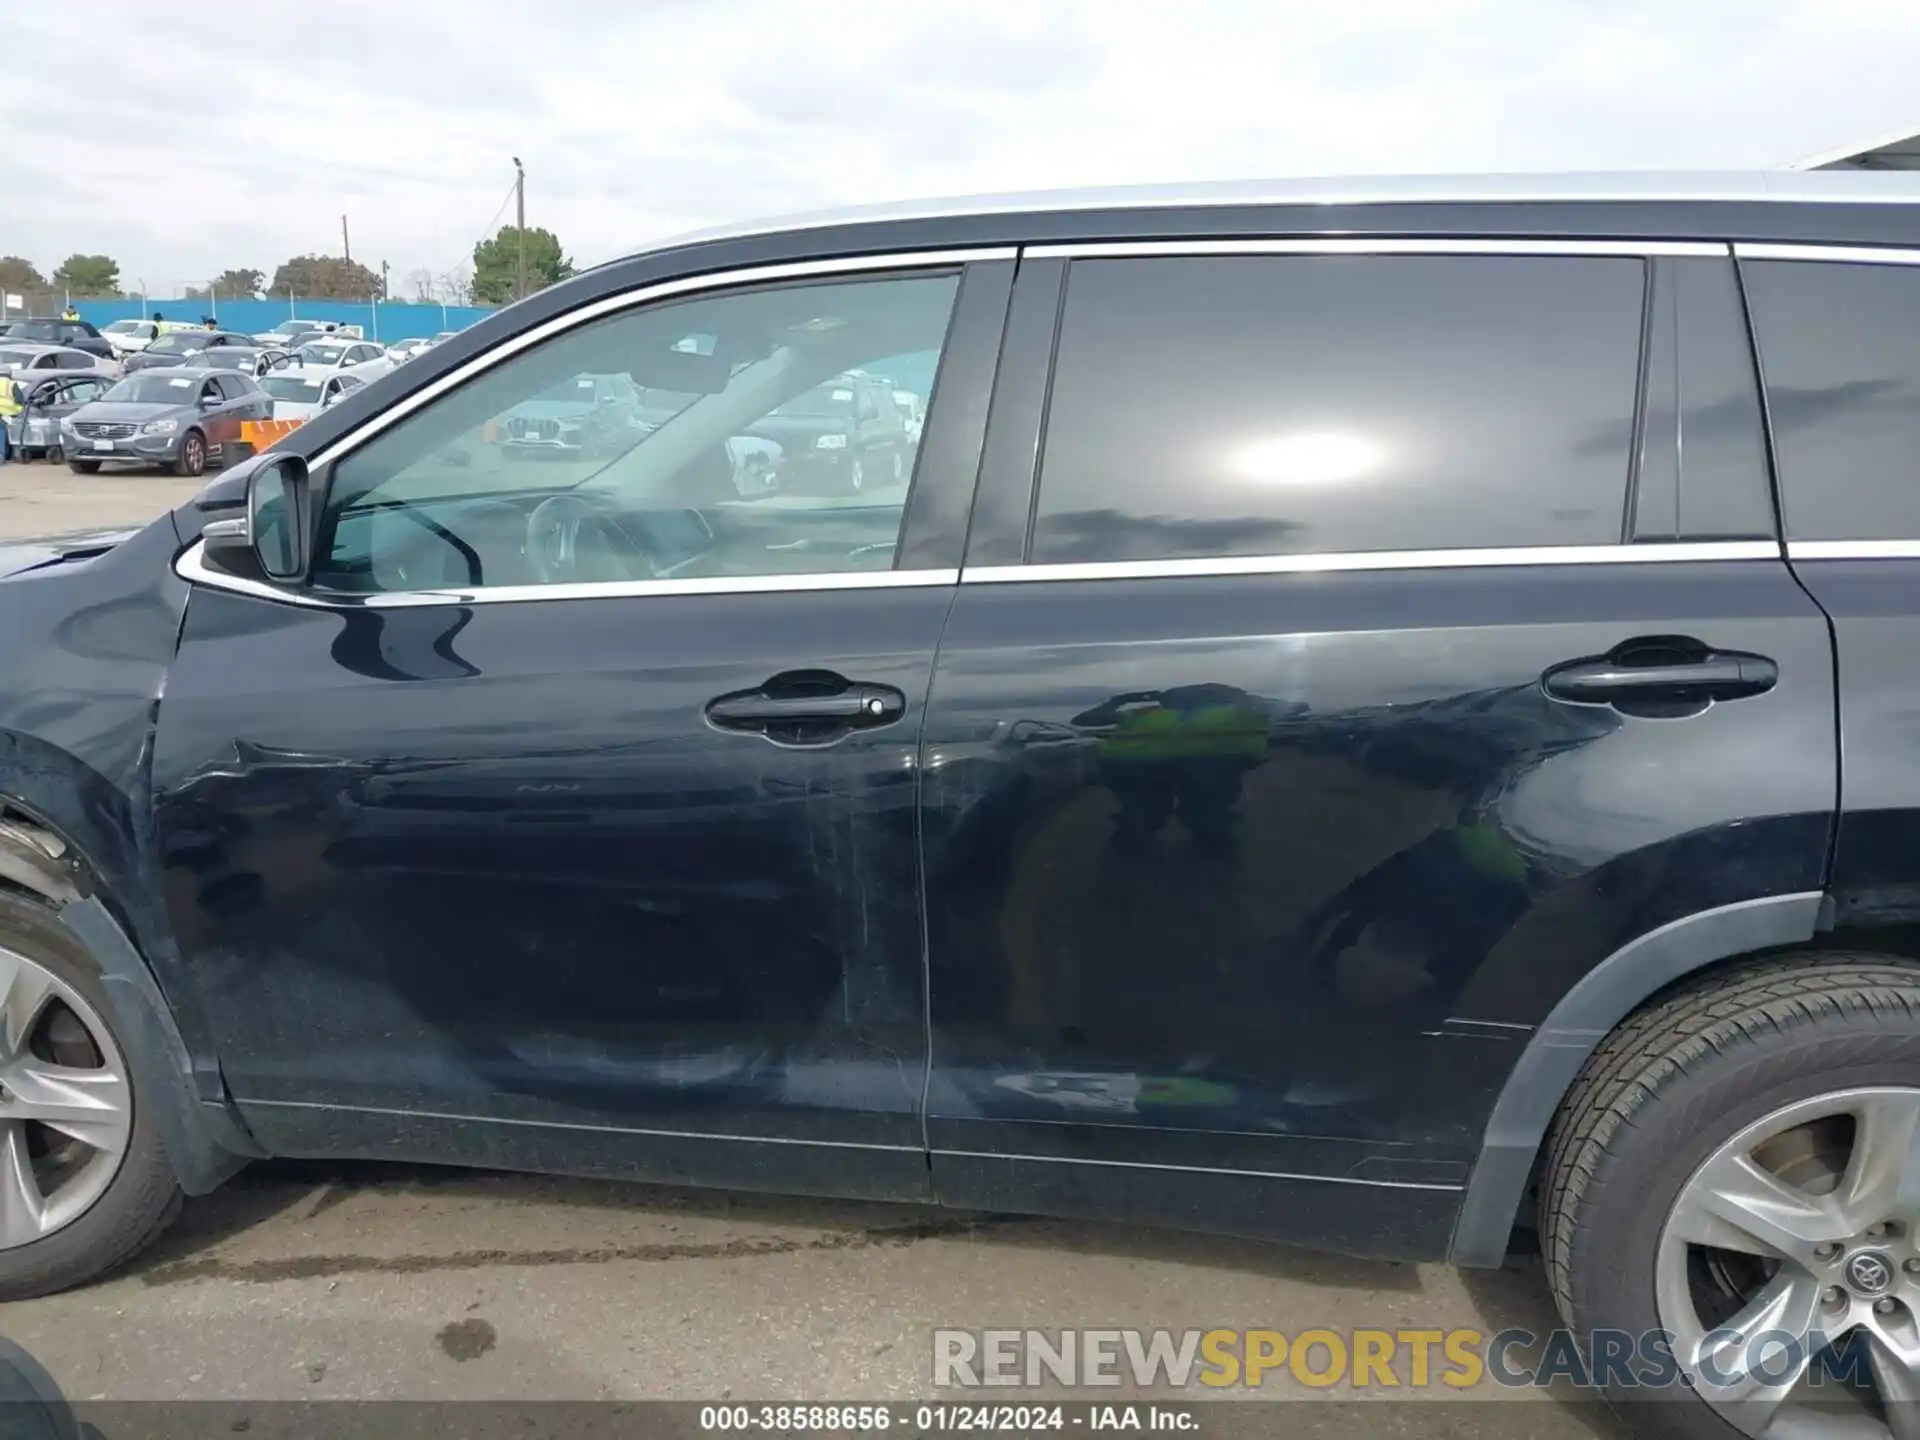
[313,271,975,593]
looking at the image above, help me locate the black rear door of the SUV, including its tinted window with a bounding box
[924,240,1836,1254]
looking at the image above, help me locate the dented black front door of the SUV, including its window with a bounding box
[154,259,1010,1196]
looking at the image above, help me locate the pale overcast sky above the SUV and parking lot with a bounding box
[0,0,1920,296]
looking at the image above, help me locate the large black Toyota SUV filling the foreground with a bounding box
[0,175,1920,1434]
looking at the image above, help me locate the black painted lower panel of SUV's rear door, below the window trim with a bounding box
[924,563,1834,1250]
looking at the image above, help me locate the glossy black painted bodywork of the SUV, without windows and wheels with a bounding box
[0,189,1920,1256]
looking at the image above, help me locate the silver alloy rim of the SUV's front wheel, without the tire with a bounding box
[0,948,132,1250]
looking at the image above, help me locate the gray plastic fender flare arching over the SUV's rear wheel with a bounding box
[1448,891,1826,1265]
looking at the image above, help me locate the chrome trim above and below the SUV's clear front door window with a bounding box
[173,246,1020,611]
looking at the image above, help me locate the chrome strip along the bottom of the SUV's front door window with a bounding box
[173,540,960,611]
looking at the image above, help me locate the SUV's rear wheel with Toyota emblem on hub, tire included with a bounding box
[1540,954,1920,1440]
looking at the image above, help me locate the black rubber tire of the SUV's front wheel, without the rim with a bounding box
[0,891,180,1300]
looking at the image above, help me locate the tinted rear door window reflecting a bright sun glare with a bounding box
[1033,255,1645,564]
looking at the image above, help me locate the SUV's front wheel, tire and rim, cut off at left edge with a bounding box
[0,893,180,1300]
